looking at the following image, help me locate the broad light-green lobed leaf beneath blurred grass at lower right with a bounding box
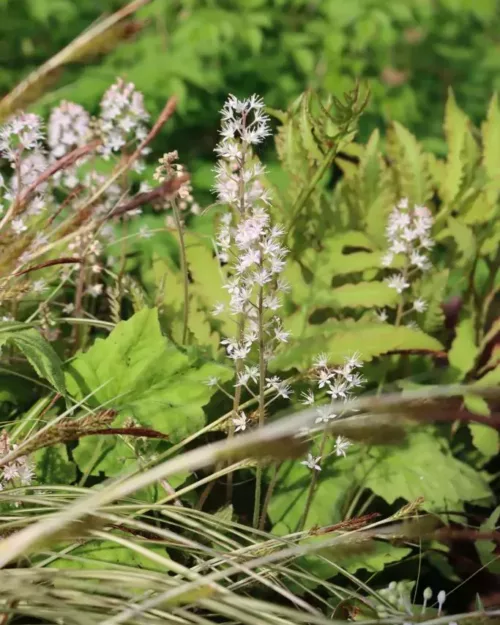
[356,428,492,511]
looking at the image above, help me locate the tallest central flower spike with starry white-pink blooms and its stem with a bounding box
[215,95,290,526]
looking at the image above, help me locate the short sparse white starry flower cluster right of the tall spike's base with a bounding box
[302,353,364,471]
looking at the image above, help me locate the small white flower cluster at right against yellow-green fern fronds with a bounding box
[379,198,434,321]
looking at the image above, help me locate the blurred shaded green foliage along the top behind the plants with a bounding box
[0,0,500,188]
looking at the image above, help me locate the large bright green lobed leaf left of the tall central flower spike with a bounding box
[66,308,233,442]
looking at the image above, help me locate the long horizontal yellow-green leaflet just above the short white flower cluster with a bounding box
[272,321,443,370]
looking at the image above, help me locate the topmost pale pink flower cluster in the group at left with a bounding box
[101,79,149,158]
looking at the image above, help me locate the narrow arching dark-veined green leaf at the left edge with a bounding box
[0,322,66,396]
